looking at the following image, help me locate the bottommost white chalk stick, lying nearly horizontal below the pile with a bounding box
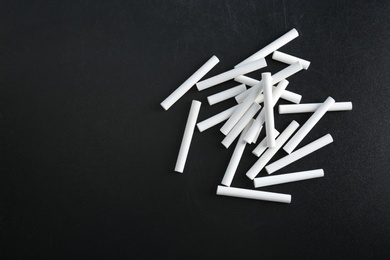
[217,185,291,203]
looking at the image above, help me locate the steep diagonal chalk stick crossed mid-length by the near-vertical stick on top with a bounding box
[244,80,289,143]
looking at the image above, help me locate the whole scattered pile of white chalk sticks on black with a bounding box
[161,29,352,203]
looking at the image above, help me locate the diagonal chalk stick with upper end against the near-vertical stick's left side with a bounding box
[220,82,263,135]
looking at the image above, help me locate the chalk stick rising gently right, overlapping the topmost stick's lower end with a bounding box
[196,59,267,91]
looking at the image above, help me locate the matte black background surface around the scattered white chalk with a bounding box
[0,0,390,259]
